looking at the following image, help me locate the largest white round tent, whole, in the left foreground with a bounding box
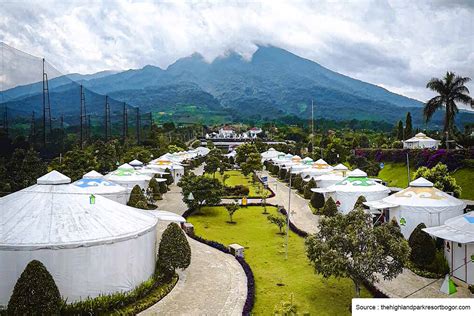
[0,171,158,305]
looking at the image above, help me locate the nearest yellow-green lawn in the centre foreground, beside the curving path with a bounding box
[188,206,370,315]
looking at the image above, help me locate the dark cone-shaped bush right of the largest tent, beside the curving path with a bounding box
[157,223,191,276]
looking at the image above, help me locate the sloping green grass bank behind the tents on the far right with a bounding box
[378,163,474,200]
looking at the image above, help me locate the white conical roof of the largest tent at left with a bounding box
[0,171,157,250]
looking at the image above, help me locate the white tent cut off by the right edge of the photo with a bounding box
[423,212,474,284]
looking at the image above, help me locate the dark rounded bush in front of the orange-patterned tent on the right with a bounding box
[408,223,436,268]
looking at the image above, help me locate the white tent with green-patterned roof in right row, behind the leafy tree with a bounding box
[311,169,390,214]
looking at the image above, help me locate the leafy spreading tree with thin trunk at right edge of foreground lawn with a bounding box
[305,209,410,297]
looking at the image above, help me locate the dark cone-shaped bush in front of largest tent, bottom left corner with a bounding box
[7,260,62,315]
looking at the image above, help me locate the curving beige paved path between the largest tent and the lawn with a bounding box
[140,170,247,315]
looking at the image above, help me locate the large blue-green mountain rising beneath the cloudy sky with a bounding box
[1,46,474,125]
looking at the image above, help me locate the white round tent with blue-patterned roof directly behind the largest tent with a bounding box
[73,170,130,204]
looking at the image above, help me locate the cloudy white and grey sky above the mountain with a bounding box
[0,0,474,106]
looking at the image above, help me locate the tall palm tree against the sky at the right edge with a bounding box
[423,71,472,143]
